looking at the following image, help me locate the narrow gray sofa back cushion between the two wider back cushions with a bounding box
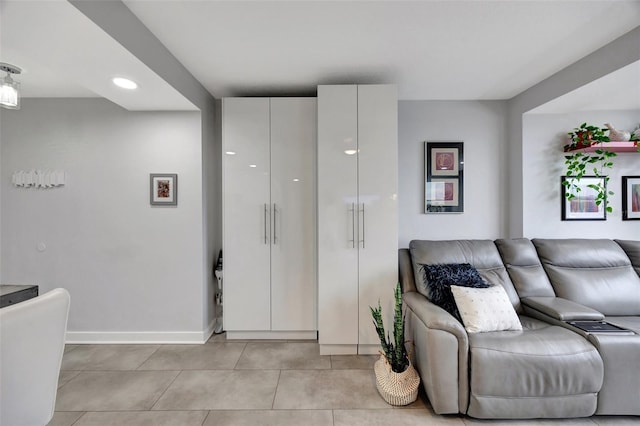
[496,238,555,298]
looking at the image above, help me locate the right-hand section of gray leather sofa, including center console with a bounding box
[520,239,640,415]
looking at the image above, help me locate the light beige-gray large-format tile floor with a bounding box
[49,335,640,426]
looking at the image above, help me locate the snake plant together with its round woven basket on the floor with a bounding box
[369,283,420,405]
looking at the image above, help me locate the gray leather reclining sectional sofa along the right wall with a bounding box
[399,239,640,420]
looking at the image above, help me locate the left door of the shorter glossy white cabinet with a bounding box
[222,98,271,331]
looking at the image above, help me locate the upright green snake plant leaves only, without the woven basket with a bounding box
[369,283,409,373]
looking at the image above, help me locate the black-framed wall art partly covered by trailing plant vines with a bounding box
[561,176,607,220]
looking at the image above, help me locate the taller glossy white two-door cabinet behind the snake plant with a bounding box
[318,85,398,354]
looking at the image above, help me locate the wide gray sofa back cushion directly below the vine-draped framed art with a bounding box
[532,239,640,316]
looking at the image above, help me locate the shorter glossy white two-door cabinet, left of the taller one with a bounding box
[223,98,317,339]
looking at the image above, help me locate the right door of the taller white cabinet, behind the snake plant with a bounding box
[358,85,398,345]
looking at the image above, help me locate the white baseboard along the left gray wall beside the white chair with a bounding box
[65,322,214,345]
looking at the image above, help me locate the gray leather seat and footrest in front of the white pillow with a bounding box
[468,316,603,418]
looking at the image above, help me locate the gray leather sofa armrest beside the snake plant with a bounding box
[403,291,469,414]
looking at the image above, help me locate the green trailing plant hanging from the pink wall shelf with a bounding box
[562,123,617,213]
